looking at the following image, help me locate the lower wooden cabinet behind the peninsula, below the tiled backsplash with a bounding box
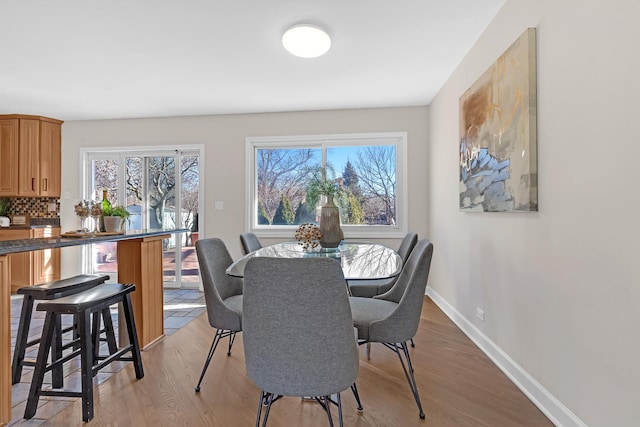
[0,227,60,293]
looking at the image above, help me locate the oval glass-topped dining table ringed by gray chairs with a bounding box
[227,240,402,280]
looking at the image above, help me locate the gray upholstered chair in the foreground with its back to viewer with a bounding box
[242,257,362,426]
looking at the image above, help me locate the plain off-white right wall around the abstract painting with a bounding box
[429,0,640,426]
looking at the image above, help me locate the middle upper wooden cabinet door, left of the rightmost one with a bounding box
[18,119,40,197]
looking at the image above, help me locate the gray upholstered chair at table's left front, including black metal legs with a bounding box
[196,238,242,392]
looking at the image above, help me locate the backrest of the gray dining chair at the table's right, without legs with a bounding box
[369,239,433,342]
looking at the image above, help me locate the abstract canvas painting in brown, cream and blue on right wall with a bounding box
[459,28,538,212]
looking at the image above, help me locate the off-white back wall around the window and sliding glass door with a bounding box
[60,107,428,275]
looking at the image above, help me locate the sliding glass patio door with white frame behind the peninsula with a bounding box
[85,150,200,288]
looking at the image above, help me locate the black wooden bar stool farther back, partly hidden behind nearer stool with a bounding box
[11,274,109,387]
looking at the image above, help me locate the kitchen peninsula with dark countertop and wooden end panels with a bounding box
[0,229,189,426]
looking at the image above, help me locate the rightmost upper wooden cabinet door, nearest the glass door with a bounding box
[39,121,62,197]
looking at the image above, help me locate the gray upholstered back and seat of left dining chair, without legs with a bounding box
[196,237,242,331]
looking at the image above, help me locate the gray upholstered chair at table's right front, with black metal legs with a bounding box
[349,240,433,419]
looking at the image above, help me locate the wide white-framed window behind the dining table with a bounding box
[247,132,407,238]
